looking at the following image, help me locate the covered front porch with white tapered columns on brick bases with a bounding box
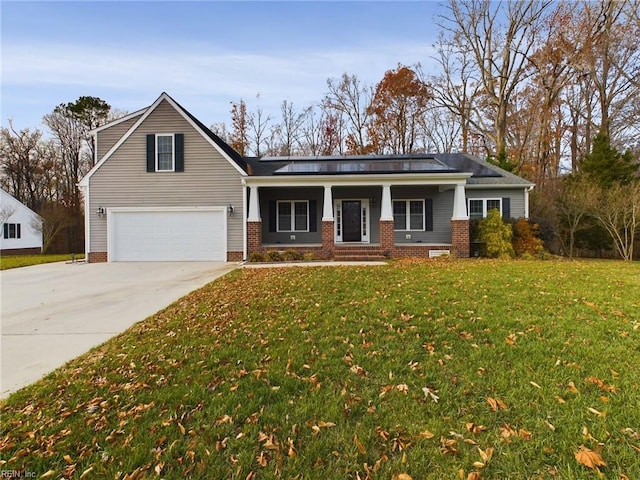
[245,172,470,260]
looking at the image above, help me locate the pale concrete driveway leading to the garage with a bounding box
[0,262,238,398]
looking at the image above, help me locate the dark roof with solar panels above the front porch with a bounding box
[245,153,533,187]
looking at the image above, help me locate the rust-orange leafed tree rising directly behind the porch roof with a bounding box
[367,65,432,154]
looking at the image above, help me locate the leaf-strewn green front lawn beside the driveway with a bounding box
[0,259,640,480]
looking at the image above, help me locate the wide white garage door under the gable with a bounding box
[108,207,227,262]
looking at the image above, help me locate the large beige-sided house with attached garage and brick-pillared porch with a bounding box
[80,93,533,262]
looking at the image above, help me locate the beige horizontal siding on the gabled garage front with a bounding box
[89,101,244,252]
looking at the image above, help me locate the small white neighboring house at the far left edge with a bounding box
[0,190,42,255]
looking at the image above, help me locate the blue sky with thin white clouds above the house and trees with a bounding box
[0,0,443,128]
